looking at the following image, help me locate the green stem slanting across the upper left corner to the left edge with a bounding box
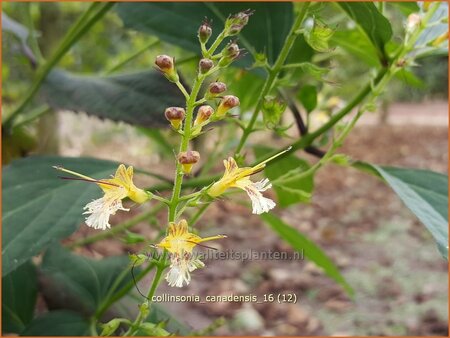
[2,2,114,130]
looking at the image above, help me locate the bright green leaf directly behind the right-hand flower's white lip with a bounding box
[254,146,314,207]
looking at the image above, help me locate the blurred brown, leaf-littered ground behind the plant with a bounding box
[63,103,448,335]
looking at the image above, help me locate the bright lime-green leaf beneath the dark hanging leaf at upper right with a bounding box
[331,29,380,67]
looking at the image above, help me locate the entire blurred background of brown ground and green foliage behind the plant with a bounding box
[2,2,448,335]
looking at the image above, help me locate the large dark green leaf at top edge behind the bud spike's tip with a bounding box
[116,2,293,66]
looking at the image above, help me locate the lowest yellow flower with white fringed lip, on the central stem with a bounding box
[156,219,227,287]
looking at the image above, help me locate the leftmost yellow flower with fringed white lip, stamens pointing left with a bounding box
[53,164,151,230]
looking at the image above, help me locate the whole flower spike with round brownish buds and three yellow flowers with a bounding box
[55,11,287,287]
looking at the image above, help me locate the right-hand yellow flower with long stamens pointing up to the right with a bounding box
[208,147,291,215]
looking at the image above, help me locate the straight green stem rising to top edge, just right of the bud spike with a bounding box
[235,2,310,154]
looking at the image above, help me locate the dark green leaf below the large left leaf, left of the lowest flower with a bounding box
[41,245,132,315]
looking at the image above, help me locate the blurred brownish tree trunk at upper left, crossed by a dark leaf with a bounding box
[37,2,61,154]
